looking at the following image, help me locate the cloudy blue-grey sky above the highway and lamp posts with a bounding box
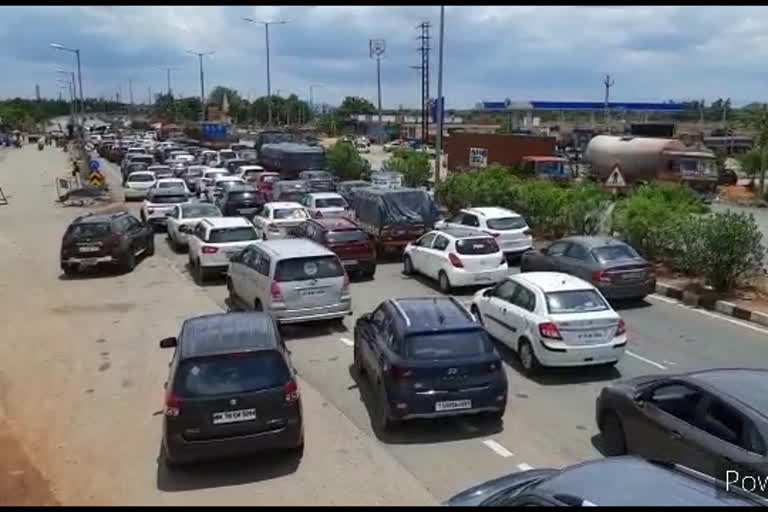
[0,6,768,108]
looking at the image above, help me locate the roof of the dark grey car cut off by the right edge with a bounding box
[686,368,768,417]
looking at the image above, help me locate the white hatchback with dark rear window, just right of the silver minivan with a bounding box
[403,228,509,293]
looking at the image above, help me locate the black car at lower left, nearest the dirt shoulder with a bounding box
[160,313,304,469]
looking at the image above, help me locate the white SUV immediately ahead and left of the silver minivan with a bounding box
[187,217,258,284]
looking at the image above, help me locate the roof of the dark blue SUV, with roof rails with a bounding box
[389,296,482,333]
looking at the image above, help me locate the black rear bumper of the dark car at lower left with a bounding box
[163,420,304,463]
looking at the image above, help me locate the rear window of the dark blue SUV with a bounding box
[405,331,493,359]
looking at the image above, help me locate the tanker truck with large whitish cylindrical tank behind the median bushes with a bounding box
[584,135,718,196]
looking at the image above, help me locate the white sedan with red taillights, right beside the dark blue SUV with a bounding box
[472,272,627,375]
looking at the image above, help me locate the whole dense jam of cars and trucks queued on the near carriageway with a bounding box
[61,132,768,506]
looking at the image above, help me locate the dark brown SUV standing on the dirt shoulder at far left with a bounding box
[60,212,155,276]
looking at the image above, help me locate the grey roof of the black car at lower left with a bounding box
[179,312,279,359]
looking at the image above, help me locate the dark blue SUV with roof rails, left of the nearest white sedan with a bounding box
[353,297,507,430]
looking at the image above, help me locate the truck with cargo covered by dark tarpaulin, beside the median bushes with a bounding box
[351,187,440,255]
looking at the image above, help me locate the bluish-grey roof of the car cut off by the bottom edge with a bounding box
[535,456,757,506]
